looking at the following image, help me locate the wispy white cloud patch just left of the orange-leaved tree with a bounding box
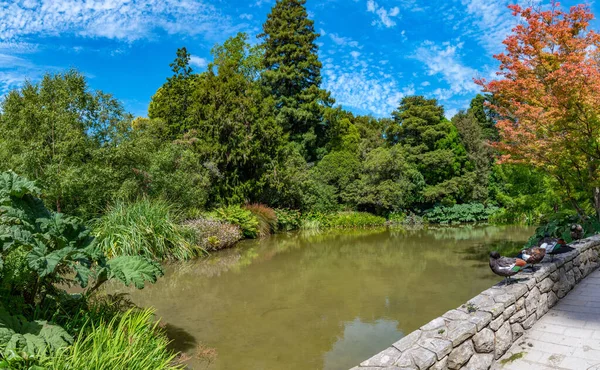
[413,41,479,95]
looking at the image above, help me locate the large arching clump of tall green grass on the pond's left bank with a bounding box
[93,199,202,260]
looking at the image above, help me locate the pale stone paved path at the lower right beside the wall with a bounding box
[492,270,600,370]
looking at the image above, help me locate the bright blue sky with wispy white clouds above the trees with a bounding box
[0,0,600,117]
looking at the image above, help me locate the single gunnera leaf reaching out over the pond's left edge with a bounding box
[106,256,163,289]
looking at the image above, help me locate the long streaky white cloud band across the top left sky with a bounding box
[0,0,236,42]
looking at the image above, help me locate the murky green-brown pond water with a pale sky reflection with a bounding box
[112,226,533,370]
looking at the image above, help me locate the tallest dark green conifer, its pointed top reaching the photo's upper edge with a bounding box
[258,0,333,161]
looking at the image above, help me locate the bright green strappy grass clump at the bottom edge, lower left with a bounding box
[48,309,184,370]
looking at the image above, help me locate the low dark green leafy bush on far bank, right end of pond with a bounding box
[425,203,499,224]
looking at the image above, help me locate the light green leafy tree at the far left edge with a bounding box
[0,70,130,216]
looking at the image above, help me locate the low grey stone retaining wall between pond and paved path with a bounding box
[351,236,600,370]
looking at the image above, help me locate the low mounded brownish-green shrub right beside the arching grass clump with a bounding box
[184,218,244,251]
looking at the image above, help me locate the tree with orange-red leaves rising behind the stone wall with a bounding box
[476,3,600,218]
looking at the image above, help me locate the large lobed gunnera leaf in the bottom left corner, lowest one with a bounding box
[0,307,73,356]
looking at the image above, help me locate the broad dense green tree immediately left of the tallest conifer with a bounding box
[182,33,286,204]
